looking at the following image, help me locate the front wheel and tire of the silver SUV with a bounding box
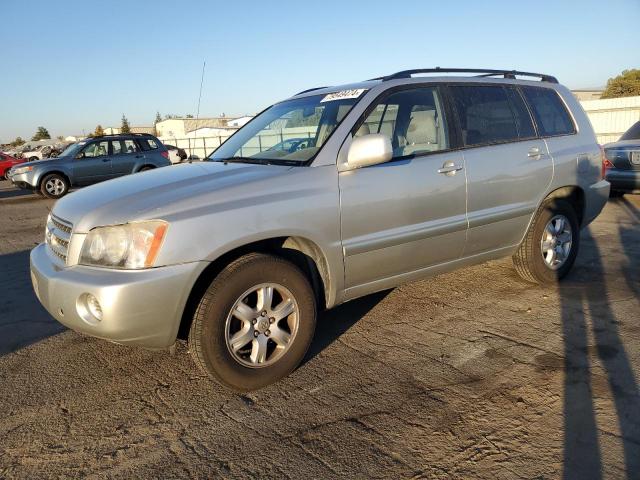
[188,253,316,392]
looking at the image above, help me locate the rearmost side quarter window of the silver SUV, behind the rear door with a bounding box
[521,87,576,137]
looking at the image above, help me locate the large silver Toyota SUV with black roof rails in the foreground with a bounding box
[31,69,609,390]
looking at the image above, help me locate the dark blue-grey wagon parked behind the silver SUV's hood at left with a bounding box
[8,134,171,198]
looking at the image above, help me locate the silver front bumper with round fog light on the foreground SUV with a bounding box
[30,244,207,348]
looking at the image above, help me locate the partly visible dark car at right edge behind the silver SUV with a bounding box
[603,121,640,197]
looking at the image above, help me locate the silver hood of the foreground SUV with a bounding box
[53,162,294,233]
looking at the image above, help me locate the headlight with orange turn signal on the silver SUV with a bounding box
[80,220,169,270]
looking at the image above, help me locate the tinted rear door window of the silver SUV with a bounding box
[450,85,535,146]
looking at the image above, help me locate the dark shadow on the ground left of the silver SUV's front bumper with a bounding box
[0,250,65,355]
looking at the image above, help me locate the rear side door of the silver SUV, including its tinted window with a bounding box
[449,84,553,257]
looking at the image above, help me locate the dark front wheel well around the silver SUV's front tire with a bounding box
[178,236,333,339]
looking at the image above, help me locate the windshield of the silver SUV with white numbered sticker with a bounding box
[208,89,364,165]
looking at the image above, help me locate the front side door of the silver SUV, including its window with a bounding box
[339,86,467,297]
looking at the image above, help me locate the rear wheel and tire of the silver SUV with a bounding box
[513,199,580,284]
